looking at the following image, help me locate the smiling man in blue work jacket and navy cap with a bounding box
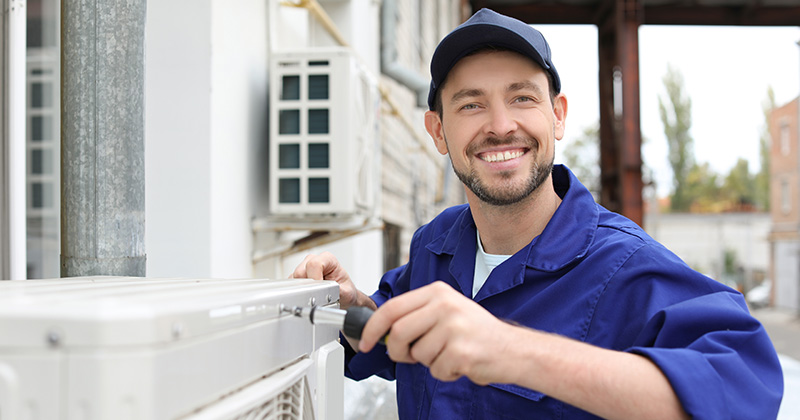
[293,9,783,419]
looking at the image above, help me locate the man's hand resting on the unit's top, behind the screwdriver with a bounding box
[290,252,376,309]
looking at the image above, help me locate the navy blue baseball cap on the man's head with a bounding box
[428,9,561,110]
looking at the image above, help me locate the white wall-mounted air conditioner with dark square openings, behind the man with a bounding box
[269,47,380,220]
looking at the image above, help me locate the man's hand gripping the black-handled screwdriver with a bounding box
[359,282,515,385]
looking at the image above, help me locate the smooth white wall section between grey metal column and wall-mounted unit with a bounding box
[145,0,268,278]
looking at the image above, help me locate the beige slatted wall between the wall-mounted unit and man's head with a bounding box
[381,0,465,262]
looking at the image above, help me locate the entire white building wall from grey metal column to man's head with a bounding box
[145,0,463,282]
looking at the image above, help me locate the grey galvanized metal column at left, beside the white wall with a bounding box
[61,0,146,277]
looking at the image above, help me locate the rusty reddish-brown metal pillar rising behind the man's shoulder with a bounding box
[598,0,644,225]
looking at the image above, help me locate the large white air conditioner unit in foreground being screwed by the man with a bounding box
[0,277,344,420]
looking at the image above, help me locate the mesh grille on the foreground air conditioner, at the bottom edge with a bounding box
[234,378,314,420]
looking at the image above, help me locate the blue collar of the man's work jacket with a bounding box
[426,165,600,276]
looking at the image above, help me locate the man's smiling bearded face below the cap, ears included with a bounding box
[425,51,567,205]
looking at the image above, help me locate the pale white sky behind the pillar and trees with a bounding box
[534,25,800,196]
